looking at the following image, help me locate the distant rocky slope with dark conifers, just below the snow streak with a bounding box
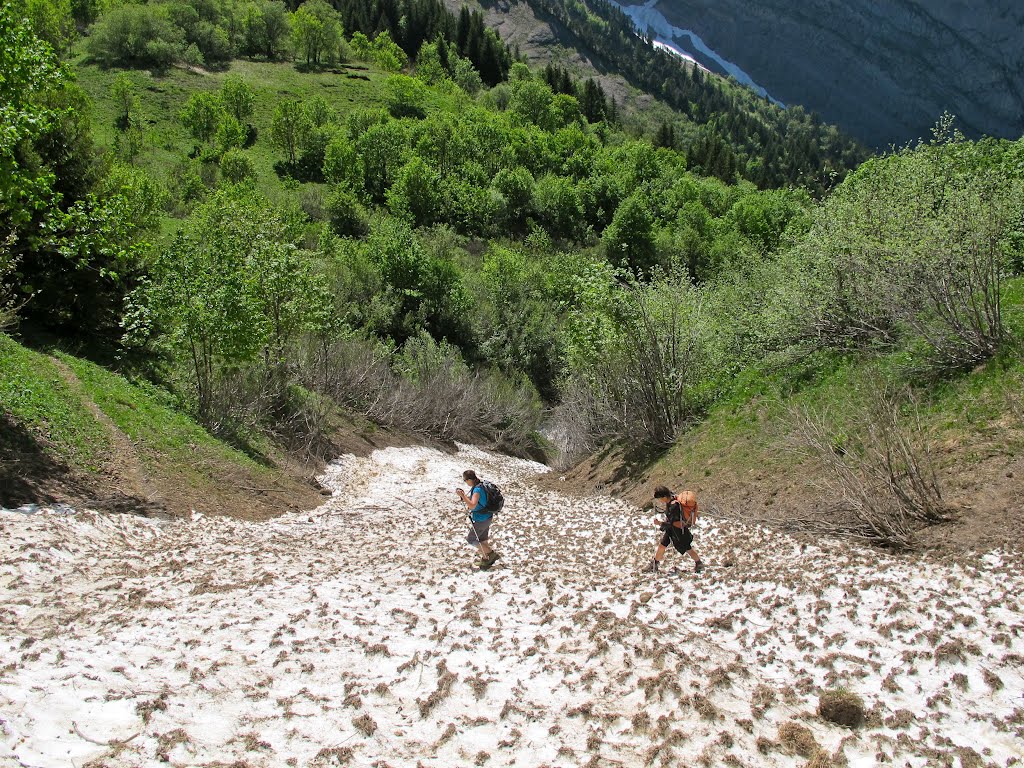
[445,0,868,193]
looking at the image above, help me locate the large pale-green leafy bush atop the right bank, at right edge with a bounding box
[801,126,1024,374]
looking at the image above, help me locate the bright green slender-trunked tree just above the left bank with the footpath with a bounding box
[138,187,327,425]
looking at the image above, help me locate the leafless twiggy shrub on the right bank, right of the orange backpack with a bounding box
[788,390,949,549]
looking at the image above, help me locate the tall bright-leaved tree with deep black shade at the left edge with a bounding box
[0,4,148,345]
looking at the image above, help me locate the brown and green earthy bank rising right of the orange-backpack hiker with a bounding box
[544,346,1024,555]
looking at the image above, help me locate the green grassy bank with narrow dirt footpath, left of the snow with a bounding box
[0,334,319,517]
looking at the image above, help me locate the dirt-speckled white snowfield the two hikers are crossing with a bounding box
[0,447,1024,768]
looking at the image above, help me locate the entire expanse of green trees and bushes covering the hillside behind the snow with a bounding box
[0,0,1024,548]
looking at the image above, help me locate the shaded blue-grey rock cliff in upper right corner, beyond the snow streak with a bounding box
[647,0,1024,147]
